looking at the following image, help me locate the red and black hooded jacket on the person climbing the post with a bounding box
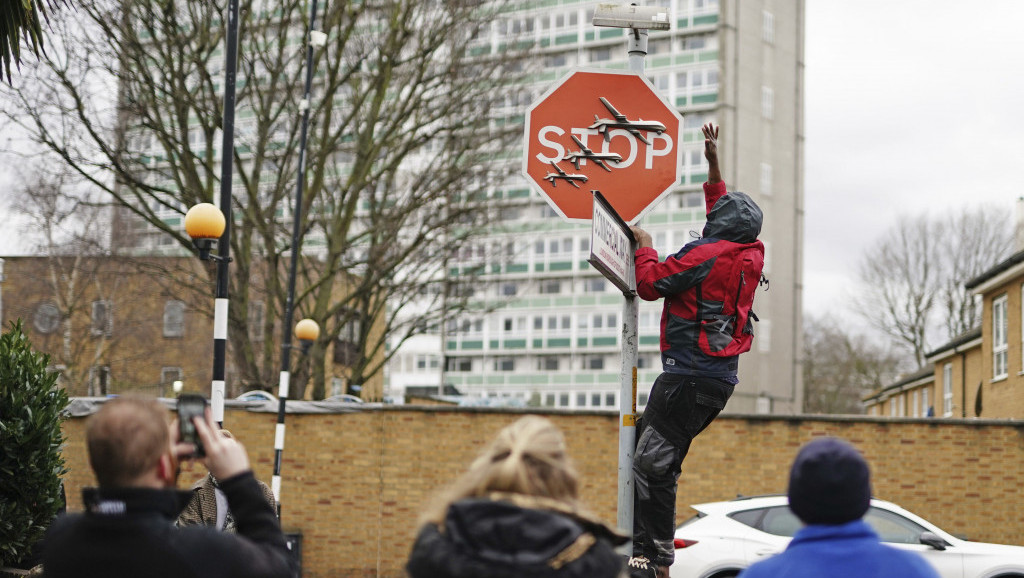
[635,182,765,383]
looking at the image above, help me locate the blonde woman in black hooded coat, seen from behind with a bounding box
[407,416,627,578]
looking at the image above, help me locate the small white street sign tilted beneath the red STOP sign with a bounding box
[587,191,637,295]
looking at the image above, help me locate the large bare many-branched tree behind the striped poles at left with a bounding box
[5,0,528,397]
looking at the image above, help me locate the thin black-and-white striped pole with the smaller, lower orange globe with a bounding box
[270,0,327,518]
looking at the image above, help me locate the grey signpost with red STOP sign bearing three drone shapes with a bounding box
[522,4,682,554]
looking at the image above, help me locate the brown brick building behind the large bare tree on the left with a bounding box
[0,255,383,400]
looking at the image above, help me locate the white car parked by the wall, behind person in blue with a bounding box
[669,496,1024,578]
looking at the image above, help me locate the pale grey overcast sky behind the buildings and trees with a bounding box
[6,0,1024,329]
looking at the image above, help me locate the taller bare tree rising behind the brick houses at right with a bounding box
[855,207,1013,367]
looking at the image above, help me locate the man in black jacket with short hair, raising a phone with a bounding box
[43,396,297,578]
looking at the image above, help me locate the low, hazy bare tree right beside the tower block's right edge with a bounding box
[804,316,904,414]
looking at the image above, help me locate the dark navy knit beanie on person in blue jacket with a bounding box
[788,438,871,526]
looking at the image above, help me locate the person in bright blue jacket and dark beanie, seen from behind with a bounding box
[739,438,938,578]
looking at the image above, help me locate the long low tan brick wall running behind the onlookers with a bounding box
[58,406,1024,577]
